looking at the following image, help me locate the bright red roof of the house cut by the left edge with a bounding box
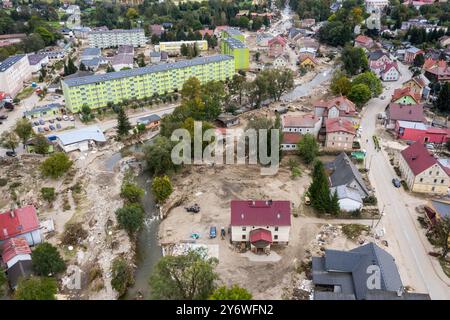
[0,205,39,240]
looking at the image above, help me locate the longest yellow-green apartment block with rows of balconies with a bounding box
[61,55,235,113]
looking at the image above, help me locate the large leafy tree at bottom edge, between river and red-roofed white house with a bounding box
[150,250,218,300]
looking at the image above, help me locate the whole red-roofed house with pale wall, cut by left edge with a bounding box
[0,205,42,246]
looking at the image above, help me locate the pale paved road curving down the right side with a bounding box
[361,65,450,299]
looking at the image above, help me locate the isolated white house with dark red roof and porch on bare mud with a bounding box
[230,200,291,253]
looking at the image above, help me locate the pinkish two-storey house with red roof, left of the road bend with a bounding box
[325,118,356,150]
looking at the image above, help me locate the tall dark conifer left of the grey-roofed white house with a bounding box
[307,161,330,213]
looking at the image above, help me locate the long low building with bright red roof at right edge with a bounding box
[394,121,450,144]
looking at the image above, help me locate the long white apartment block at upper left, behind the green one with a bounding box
[88,29,147,48]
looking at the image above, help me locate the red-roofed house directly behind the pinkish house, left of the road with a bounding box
[314,96,359,125]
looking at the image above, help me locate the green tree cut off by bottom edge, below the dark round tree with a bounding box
[14,277,58,300]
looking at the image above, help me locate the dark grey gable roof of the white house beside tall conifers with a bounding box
[327,152,369,196]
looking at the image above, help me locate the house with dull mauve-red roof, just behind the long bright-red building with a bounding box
[385,103,427,129]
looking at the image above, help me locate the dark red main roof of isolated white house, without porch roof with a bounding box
[231,200,291,227]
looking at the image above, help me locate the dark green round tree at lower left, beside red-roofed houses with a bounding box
[31,242,66,277]
